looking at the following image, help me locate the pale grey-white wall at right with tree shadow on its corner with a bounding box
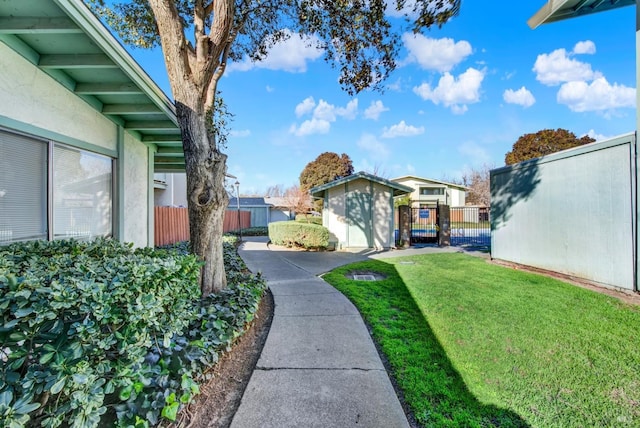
[491,135,636,289]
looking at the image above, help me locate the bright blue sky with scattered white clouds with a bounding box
[125,0,636,194]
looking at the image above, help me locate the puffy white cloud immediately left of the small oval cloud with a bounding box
[413,68,485,114]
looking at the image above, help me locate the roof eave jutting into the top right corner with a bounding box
[527,0,636,28]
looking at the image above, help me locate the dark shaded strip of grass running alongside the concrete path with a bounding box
[323,260,529,427]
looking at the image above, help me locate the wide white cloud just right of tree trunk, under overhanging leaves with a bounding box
[227,30,324,73]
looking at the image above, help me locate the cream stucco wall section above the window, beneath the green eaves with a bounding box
[0,43,117,151]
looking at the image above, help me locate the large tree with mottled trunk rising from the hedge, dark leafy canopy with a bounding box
[84,0,461,295]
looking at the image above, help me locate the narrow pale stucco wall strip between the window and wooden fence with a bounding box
[123,133,153,247]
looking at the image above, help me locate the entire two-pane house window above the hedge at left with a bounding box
[0,130,113,243]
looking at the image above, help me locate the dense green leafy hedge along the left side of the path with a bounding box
[0,239,265,427]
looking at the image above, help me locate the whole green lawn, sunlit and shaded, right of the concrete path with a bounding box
[324,254,640,428]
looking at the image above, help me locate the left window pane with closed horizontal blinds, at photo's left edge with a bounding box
[0,130,47,243]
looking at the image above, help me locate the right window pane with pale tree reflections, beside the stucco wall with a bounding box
[53,144,112,239]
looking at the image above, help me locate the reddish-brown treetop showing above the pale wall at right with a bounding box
[504,128,595,165]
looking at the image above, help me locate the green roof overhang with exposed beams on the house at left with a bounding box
[0,0,184,172]
